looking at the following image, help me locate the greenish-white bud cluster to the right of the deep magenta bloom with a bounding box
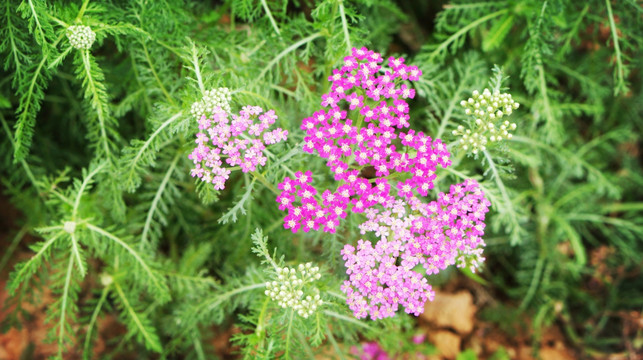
[452,89,520,154]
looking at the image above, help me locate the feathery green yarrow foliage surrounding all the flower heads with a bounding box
[0,0,643,359]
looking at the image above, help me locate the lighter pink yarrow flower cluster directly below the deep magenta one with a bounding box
[342,180,490,319]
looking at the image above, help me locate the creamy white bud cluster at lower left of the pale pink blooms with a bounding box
[265,263,323,319]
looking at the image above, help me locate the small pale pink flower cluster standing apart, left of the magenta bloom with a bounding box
[188,106,288,190]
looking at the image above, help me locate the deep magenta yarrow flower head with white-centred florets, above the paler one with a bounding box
[277,48,451,232]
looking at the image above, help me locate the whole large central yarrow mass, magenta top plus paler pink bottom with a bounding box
[277,48,489,319]
